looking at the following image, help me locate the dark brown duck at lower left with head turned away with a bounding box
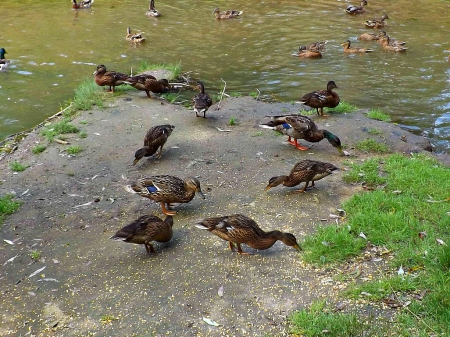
[110,215,173,254]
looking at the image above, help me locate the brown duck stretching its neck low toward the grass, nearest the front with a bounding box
[195,214,302,255]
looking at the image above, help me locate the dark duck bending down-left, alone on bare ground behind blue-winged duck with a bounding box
[133,124,175,165]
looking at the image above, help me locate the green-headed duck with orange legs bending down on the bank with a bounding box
[259,114,345,155]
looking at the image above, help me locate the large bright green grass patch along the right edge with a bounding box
[292,154,450,337]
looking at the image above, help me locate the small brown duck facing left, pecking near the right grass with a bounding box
[265,159,338,193]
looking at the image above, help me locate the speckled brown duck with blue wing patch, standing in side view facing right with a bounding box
[125,175,205,215]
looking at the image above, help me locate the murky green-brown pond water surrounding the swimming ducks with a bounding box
[0,0,450,152]
